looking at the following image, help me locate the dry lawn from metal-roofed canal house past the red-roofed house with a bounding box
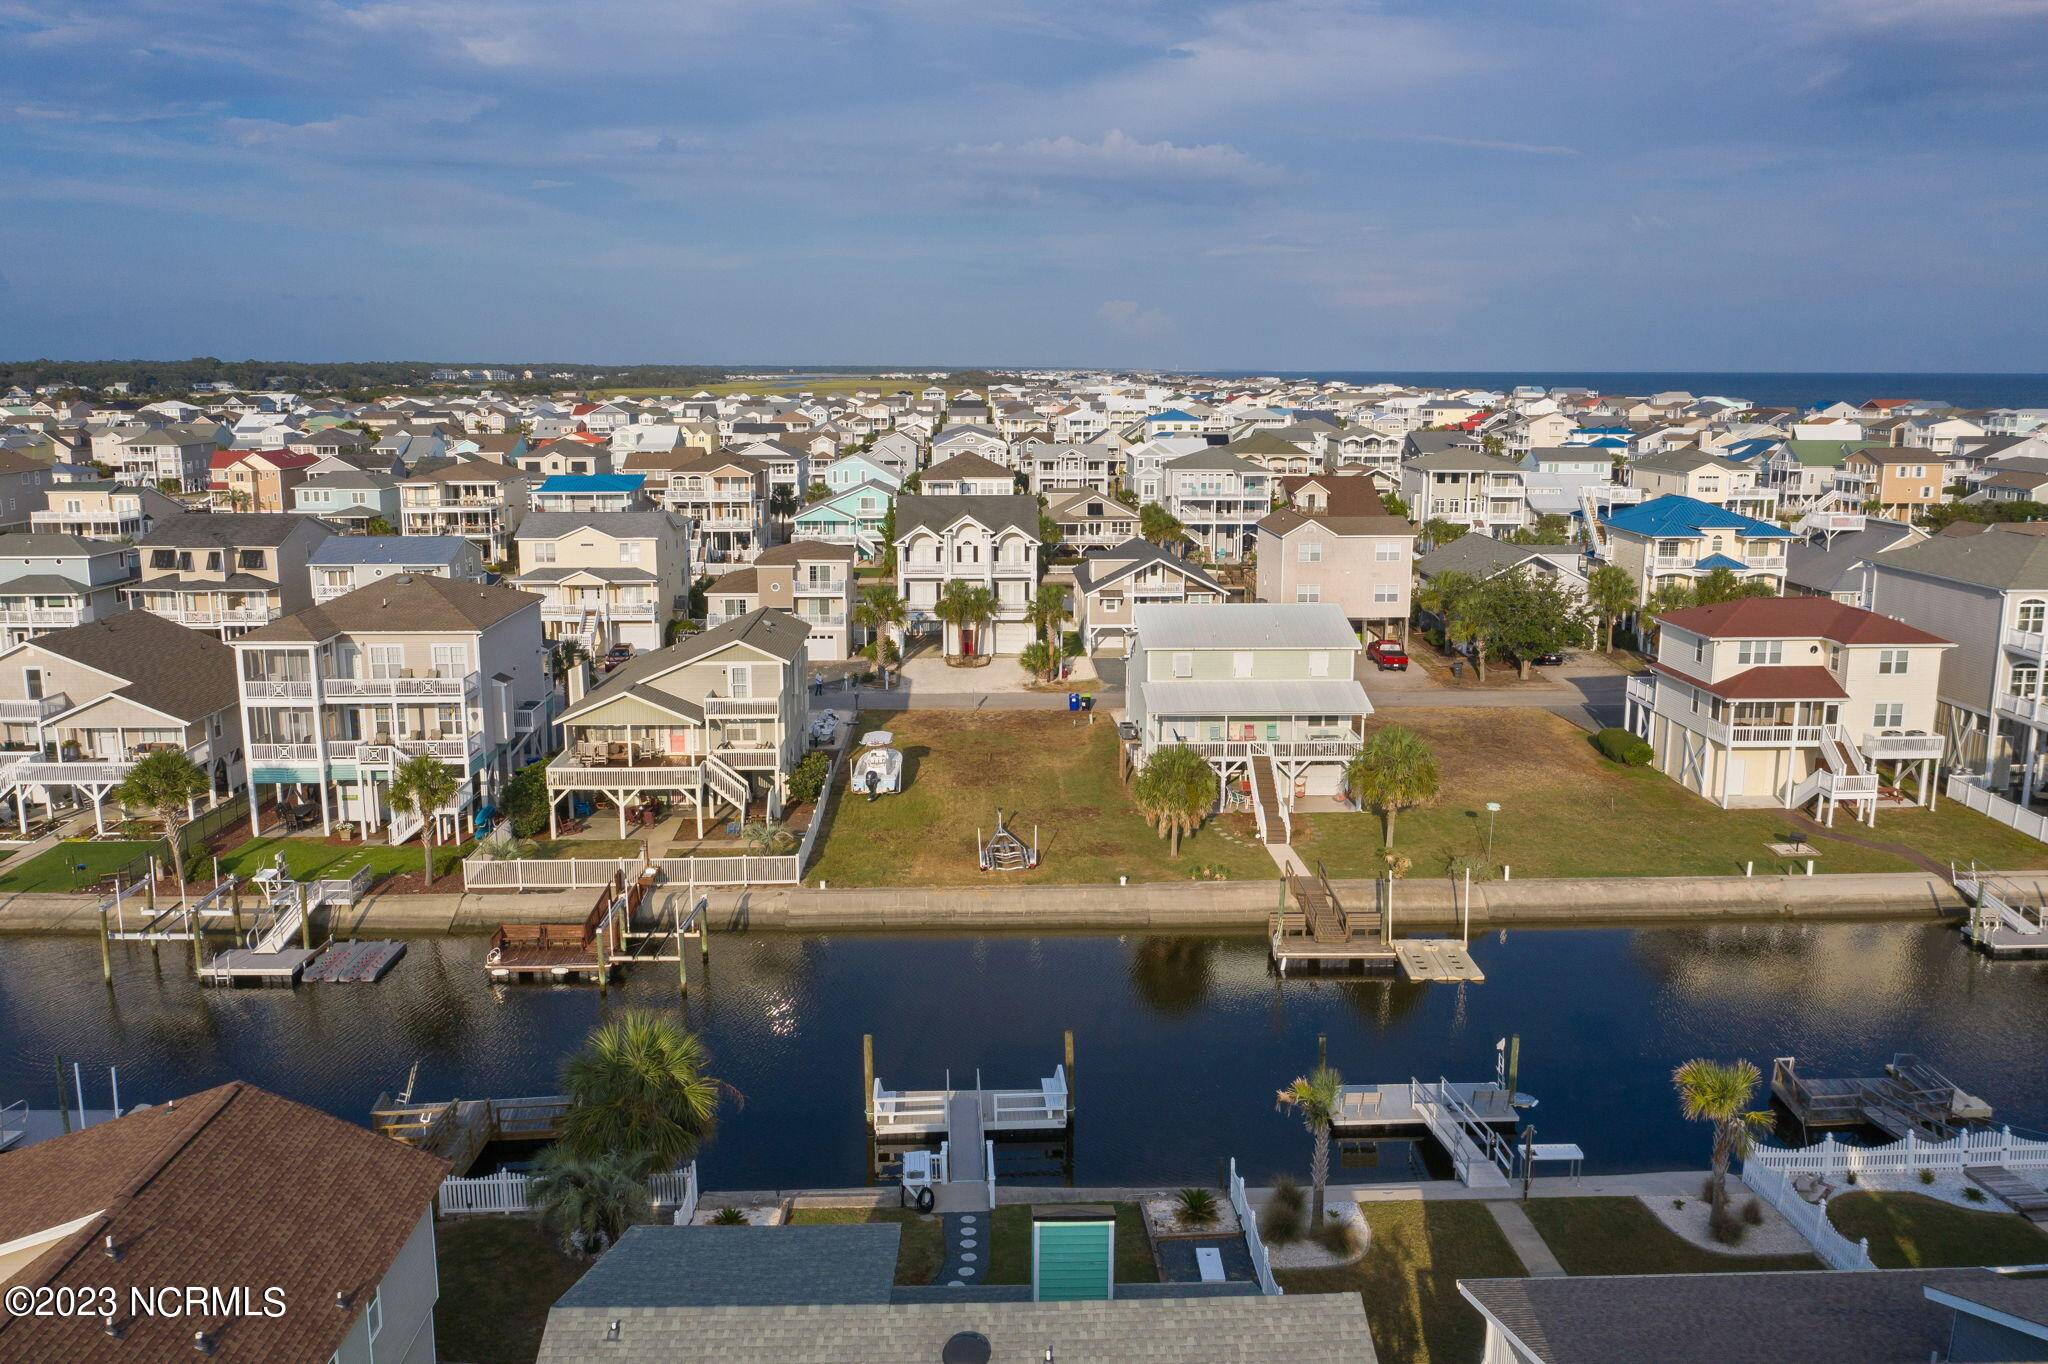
[1294,707,2048,877]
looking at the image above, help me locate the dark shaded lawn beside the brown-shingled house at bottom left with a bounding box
[434,1217,590,1364]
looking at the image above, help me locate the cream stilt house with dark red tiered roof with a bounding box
[1626,596,1954,823]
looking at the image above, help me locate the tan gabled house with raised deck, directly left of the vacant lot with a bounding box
[547,610,811,838]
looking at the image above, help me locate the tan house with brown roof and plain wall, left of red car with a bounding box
[1257,508,1415,641]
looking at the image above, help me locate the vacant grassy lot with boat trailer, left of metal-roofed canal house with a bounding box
[807,711,1278,887]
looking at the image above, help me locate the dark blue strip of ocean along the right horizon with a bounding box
[1217,369,2048,408]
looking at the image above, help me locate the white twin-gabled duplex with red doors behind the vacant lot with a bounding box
[895,494,1040,657]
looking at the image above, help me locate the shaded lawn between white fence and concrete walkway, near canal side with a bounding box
[1274,1200,1526,1364]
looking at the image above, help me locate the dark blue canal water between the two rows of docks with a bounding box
[0,922,2048,1188]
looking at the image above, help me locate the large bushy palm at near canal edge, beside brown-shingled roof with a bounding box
[561,1010,729,1176]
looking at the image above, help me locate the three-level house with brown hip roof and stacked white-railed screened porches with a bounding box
[233,573,555,844]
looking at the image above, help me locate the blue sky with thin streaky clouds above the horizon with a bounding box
[0,0,2048,371]
